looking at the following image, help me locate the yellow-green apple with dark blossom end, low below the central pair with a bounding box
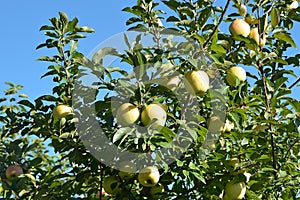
[138,166,160,187]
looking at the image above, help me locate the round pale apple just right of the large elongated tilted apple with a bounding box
[226,67,246,86]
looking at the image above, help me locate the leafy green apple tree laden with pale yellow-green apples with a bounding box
[0,0,300,200]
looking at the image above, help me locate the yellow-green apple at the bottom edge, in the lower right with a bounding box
[224,181,246,200]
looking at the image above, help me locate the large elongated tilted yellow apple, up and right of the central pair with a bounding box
[184,70,209,95]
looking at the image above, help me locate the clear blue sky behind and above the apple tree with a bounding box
[0,0,300,100]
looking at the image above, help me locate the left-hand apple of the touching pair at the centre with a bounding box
[116,103,140,126]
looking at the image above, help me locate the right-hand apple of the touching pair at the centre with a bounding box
[141,103,167,129]
